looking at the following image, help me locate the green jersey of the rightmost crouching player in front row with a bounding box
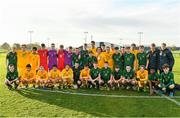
[160,72,174,86]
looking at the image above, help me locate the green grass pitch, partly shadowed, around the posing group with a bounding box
[0,54,180,117]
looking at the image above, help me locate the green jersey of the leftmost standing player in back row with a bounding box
[6,52,17,69]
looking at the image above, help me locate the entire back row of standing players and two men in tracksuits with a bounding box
[6,41,174,95]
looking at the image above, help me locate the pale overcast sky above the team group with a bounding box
[0,0,180,46]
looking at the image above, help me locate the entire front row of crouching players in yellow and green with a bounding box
[5,62,175,96]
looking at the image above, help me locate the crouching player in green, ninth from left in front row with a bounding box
[99,61,112,90]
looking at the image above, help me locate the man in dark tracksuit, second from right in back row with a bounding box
[146,43,159,72]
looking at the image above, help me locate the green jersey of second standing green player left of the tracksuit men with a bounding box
[124,53,135,69]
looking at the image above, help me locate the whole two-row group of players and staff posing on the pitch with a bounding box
[5,41,175,96]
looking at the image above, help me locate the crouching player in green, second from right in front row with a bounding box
[148,68,159,95]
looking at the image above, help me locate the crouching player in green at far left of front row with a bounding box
[5,64,19,90]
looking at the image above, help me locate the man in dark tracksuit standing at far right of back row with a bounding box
[159,43,174,73]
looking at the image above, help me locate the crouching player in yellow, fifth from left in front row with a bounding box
[61,64,73,88]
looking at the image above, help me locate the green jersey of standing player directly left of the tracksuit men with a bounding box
[137,52,147,67]
